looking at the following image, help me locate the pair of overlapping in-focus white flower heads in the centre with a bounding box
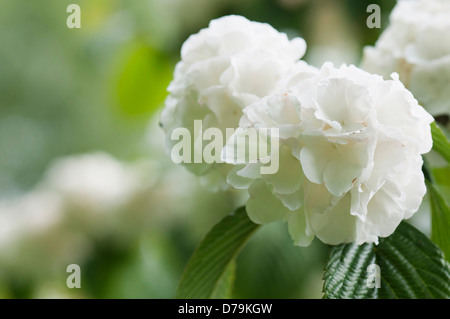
[162,16,433,246]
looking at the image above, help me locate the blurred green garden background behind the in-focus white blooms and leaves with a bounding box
[0,0,395,298]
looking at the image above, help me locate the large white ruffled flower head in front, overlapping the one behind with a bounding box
[224,63,433,246]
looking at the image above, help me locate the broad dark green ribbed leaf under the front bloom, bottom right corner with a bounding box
[323,222,450,299]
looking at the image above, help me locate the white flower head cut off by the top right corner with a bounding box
[362,0,450,115]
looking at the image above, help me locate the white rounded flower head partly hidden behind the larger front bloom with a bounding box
[161,16,306,189]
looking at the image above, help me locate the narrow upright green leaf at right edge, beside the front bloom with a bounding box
[427,181,450,261]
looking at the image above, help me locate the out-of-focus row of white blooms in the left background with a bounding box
[0,147,242,297]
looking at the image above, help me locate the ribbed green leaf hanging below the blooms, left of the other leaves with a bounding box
[175,208,259,299]
